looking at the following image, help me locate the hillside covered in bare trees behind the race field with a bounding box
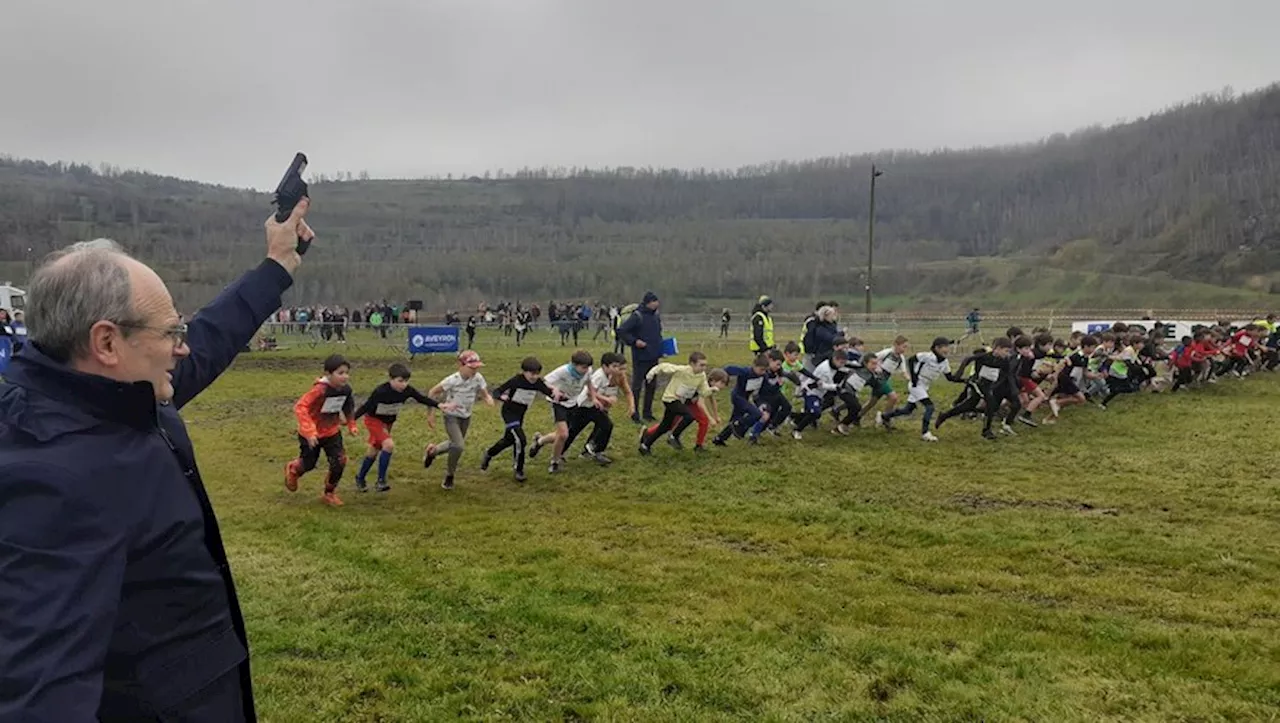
[0,86,1280,310]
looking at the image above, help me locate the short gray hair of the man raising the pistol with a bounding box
[27,238,136,363]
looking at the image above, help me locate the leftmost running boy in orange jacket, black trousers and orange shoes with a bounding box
[284,354,360,507]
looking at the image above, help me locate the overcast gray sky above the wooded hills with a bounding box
[0,0,1280,188]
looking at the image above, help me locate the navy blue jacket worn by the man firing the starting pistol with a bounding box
[0,260,293,723]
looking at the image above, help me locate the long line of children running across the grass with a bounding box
[284,315,1280,505]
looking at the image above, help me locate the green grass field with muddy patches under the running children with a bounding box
[184,327,1280,723]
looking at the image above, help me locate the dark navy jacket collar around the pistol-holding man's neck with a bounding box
[5,343,159,430]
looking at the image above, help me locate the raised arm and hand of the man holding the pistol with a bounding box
[173,198,315,408]
